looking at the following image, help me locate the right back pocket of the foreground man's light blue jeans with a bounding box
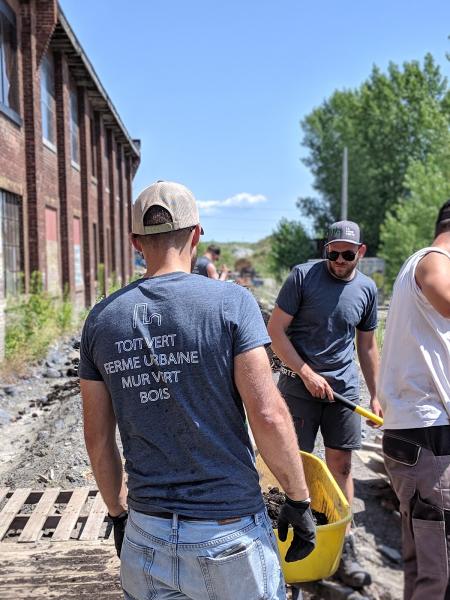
[198,539,267,600]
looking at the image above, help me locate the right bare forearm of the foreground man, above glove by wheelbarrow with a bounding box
[234,347,309,500]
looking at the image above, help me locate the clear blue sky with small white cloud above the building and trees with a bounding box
[60,0,450,242]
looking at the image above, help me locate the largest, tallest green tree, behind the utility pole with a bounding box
[298,55,450,254]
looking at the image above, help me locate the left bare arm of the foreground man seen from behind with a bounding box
[80,379,127,516]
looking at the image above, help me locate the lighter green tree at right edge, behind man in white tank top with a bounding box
[380,147,450,289]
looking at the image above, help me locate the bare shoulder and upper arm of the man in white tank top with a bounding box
[416,252,450,319]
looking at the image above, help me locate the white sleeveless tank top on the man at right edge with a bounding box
[378,247,450,429]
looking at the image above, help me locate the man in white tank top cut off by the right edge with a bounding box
[379,200,450,600]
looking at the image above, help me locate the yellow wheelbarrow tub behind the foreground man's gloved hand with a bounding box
[256,452,352,583]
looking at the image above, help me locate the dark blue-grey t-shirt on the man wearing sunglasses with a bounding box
[277,261,377,416]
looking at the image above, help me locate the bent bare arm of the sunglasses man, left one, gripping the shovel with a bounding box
[267,306,333,400]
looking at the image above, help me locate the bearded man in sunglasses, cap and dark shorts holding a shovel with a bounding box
[268,221,381,588]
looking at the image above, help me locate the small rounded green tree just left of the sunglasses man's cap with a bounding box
[269,219,313,279]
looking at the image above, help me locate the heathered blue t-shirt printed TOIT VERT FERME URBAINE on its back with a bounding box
[79,272,270,519]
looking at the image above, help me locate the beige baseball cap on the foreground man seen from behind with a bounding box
[131,181,203,235]
